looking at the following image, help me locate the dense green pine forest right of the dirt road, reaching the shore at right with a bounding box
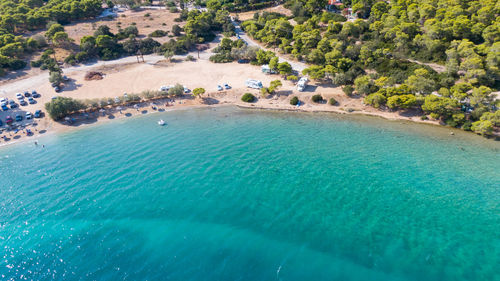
[242,0,500,135]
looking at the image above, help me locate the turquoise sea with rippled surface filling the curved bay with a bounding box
[0,107,500,281]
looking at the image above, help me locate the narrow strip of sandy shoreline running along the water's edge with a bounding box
[0,95,499,148]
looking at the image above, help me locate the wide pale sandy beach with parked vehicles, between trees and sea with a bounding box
[0,51,446,148]
